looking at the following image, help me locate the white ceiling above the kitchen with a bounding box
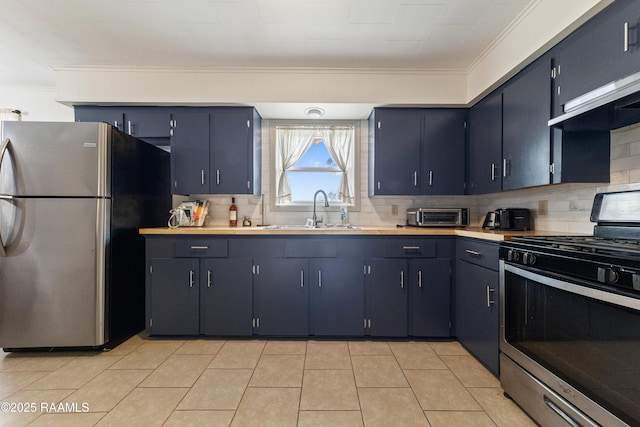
[0,0,536,86]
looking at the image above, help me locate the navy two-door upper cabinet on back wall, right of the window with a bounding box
[369,108,466,196]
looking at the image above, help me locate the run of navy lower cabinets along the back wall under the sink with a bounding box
[146,236,453,337]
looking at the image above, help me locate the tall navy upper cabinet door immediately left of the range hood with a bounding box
[502,59,551,190]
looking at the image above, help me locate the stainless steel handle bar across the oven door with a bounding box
[504,263,640,311]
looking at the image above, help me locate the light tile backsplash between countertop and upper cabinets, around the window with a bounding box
[174,120,640,233]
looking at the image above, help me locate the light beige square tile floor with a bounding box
[0,334,534,427]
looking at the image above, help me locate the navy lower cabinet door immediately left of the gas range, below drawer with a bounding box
[456,261,500,375]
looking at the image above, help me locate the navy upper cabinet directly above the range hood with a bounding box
[553,0,640,117]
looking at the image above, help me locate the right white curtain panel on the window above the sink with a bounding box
[322,128,354,204]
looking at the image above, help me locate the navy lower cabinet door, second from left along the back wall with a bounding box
[200,258,253,336]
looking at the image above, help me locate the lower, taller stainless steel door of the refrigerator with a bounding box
[0,198,111,348]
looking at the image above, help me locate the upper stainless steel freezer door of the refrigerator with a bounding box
[0,122,111,197]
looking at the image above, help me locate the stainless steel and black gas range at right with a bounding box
[500,191,640,426]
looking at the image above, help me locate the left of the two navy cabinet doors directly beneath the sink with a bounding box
[254,258,309,336]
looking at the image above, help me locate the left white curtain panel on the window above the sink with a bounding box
[276,128,317,204]
